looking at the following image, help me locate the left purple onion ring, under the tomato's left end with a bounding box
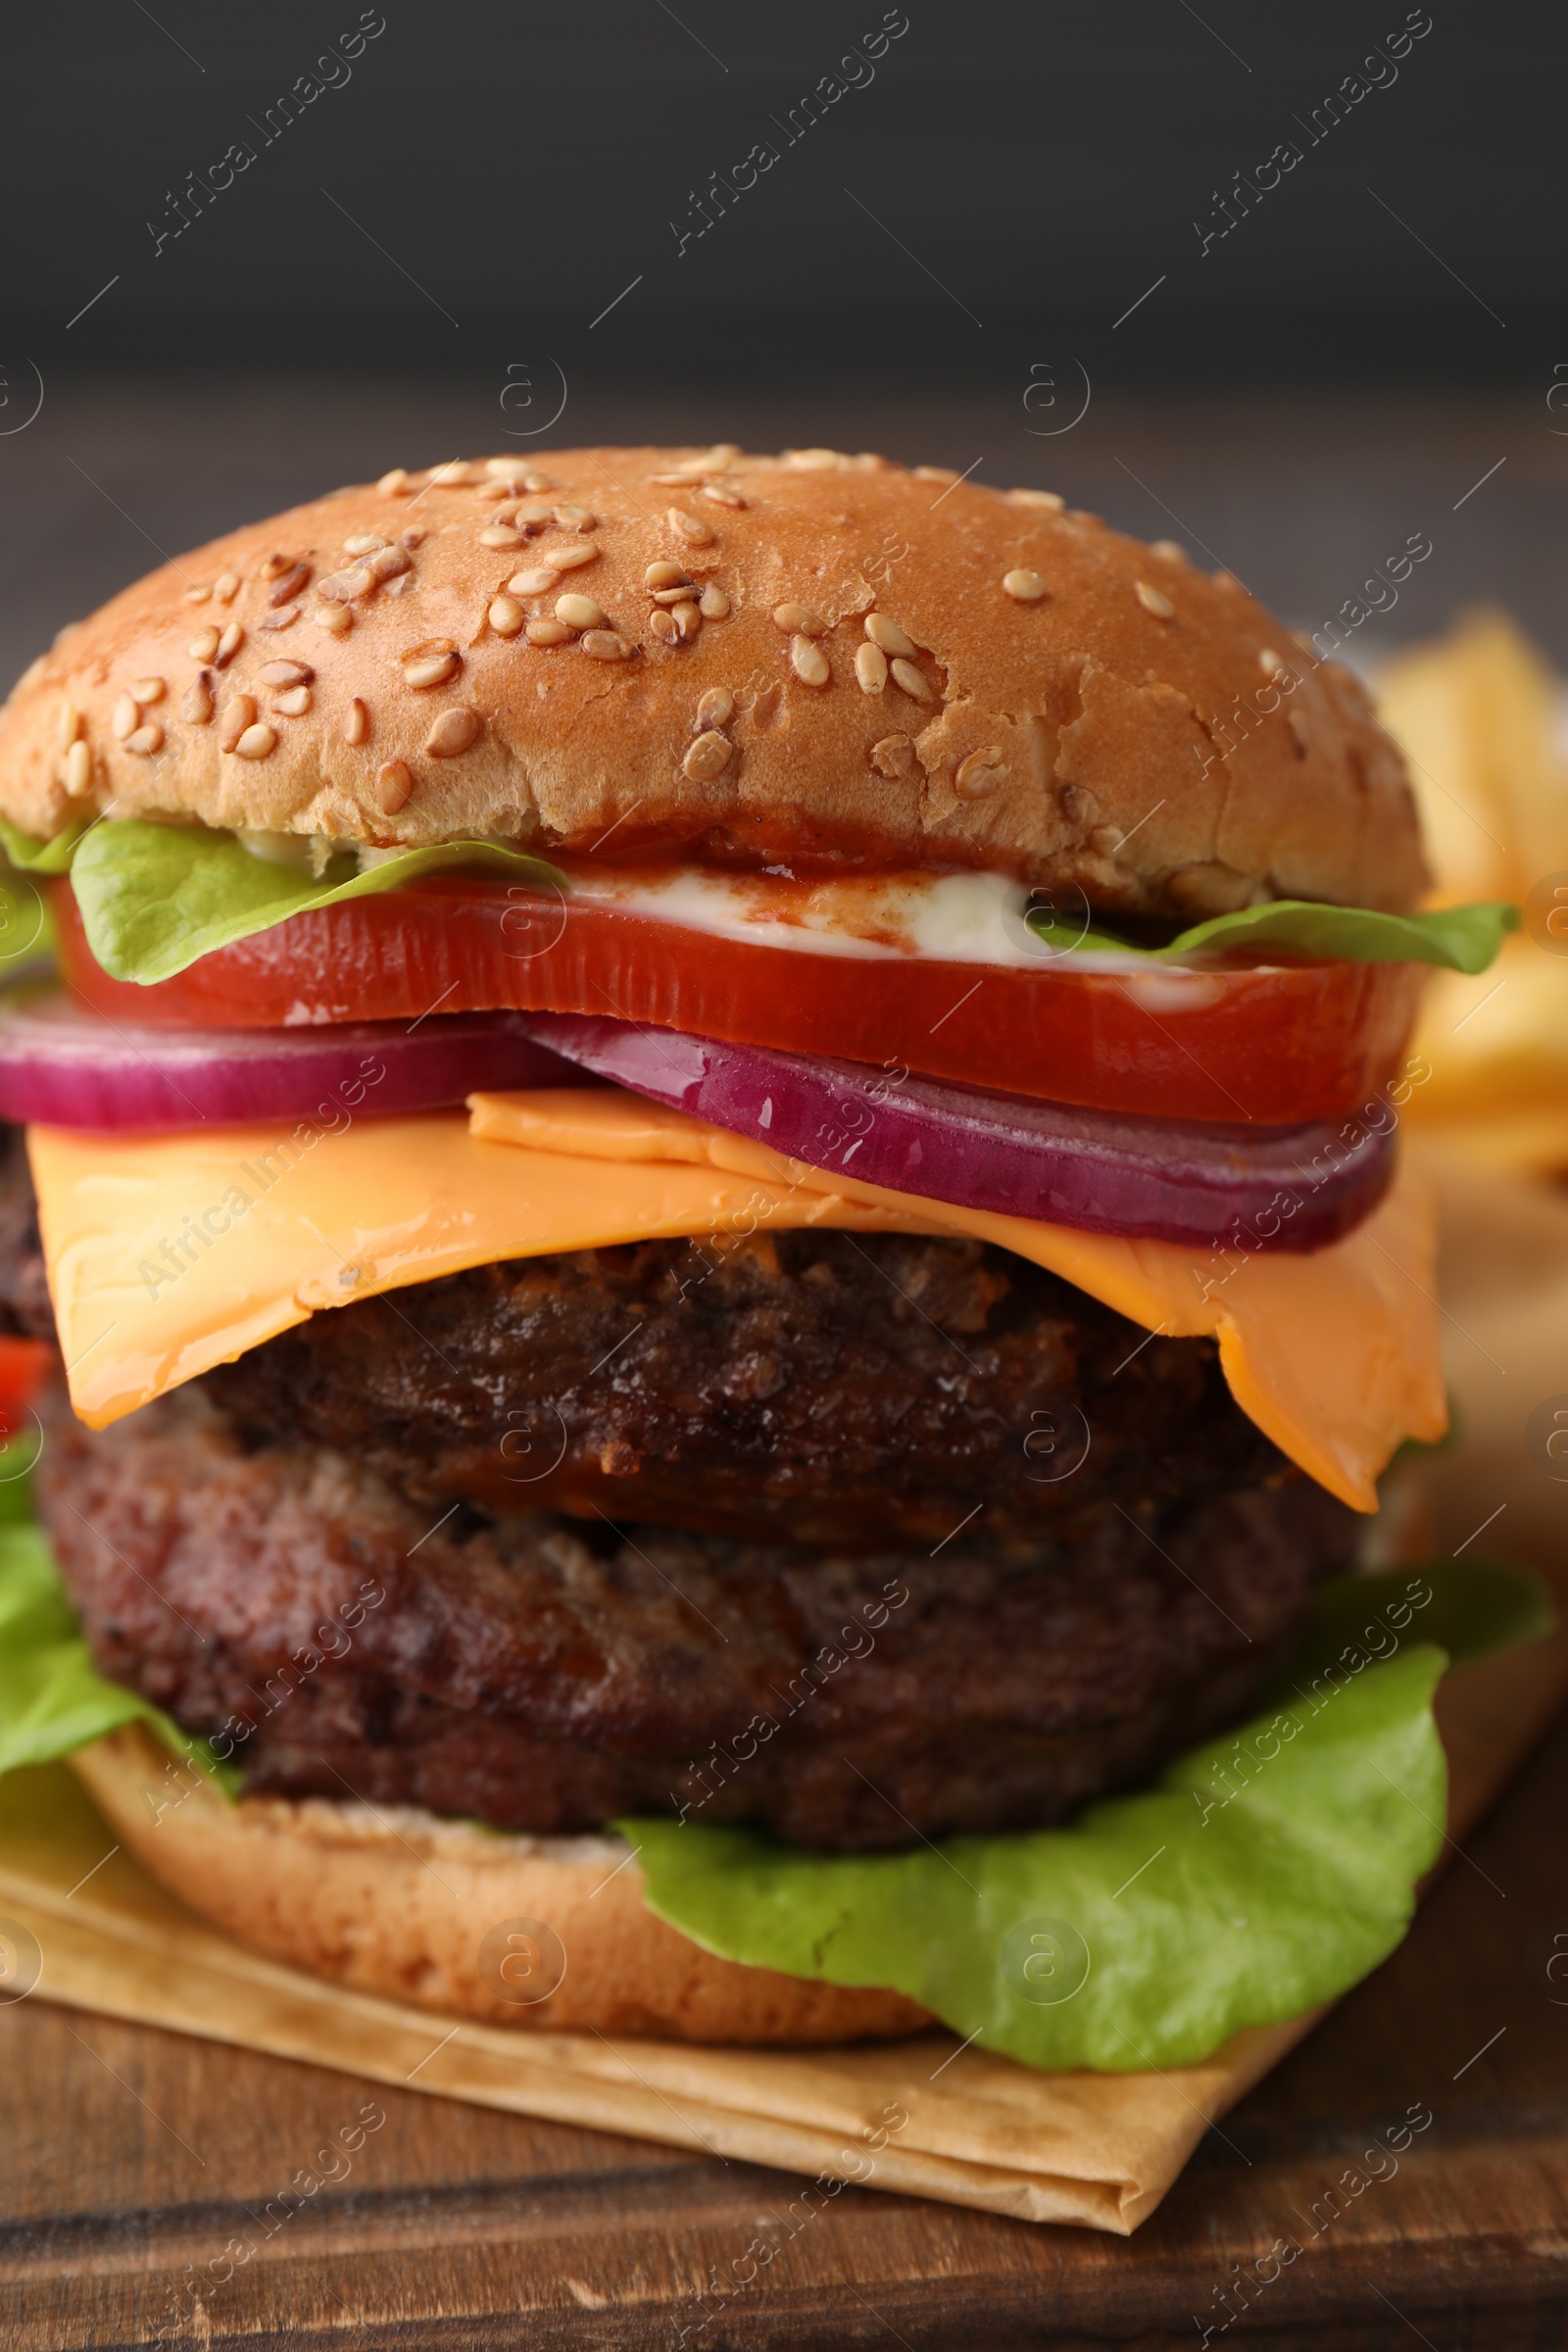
[0,990,592,1129]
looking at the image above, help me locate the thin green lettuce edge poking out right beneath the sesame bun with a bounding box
[1030,899,1519,971]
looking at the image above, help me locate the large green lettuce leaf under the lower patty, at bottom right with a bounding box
[618,1564,1549,2072]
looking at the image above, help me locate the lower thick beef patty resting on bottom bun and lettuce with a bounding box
[37,1388,1354,1848]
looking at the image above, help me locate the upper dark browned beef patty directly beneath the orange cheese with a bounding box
[0,1129,1284,1547]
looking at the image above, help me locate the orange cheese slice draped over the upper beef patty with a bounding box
[28,1089,1446,1510]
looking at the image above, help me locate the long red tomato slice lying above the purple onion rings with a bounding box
[57,875,1422,1127]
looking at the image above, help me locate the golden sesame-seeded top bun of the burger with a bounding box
[0,447,1422,915]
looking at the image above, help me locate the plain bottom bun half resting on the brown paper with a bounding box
[71,1724,933,2041]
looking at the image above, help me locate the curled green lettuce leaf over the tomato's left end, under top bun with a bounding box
[69,818,566,981]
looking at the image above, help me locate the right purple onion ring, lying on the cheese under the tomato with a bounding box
[514,1013,1396,1251]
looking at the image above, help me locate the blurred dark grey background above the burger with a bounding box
[0,0,1568,680]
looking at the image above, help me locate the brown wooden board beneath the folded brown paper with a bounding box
[0,1693,1568,2352]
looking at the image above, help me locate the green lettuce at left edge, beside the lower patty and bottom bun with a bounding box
[0,1480,240,1794]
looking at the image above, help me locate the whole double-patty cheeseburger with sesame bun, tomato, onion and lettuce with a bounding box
[0,445,1507,2068]
